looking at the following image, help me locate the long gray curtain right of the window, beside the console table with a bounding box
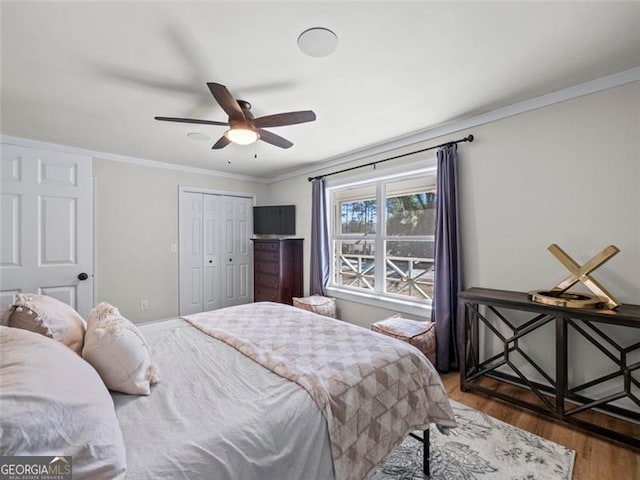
[431,144,463,372]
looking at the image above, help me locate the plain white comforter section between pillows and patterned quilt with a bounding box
[113,320,334,480]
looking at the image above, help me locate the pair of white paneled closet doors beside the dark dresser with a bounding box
[178,191,253,315]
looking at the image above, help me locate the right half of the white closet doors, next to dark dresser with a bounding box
[222,196,253,307]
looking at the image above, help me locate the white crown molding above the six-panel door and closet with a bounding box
[0,135,271,183]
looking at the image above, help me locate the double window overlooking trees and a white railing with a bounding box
[328,169,436,306]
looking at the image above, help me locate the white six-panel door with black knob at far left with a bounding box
[0,144,93,317]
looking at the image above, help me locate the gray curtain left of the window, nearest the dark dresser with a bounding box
[309,178,329,295]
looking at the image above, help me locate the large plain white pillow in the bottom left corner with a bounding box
[0,326,126,480]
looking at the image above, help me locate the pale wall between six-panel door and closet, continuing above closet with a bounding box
[93,158,267,322]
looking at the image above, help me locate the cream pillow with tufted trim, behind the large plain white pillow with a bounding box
[9,293,86,354]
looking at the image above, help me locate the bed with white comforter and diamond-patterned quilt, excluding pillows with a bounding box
[0,302,455,480]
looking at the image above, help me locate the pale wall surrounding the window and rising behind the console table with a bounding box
[265,82,640,328]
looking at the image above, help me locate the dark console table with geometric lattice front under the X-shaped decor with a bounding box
[458,288,640,448]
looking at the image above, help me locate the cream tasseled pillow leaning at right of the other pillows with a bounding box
[82,302,158,395]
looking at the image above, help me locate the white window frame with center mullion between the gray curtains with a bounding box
[326,157,437,316]
